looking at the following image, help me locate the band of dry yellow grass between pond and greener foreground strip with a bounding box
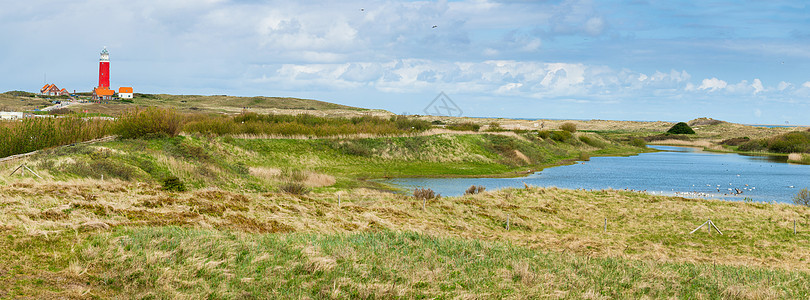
[0,175,810,270]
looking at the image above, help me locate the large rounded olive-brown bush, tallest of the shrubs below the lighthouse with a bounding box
[115,107,180,139]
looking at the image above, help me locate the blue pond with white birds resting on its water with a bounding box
[380,146,810,203]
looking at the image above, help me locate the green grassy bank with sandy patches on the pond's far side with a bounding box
[9,129,645,192]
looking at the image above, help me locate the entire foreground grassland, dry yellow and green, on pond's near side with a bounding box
[0,180,810,298]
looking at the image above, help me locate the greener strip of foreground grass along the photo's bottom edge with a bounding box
[0,227,810,299]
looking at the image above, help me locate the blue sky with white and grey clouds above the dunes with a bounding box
[0,0,810,125]
